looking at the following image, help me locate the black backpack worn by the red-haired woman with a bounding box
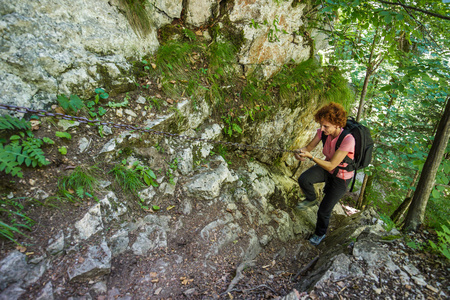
[322,117,373,191]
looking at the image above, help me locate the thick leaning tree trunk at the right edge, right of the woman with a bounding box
[405,97,450,231]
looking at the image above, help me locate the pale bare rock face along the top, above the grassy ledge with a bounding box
[0,0,323,108]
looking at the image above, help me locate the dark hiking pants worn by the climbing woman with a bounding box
[298,165,351,236]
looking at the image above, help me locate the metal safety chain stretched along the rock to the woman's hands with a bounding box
[0,104,296,153]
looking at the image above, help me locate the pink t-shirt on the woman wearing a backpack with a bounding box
[317,128,355,180]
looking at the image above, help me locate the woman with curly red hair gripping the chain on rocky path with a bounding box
[294,102,355,246]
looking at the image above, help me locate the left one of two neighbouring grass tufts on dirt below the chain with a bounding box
[58,166,100,202]
